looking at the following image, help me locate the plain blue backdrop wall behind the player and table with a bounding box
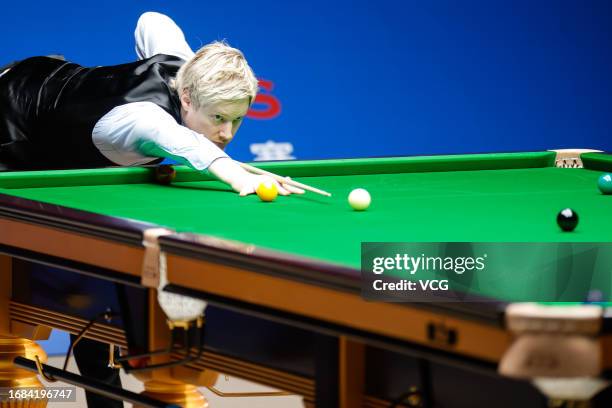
[0,0,612,160]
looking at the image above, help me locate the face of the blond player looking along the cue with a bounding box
[181,94,249,149]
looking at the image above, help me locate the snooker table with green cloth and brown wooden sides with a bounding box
[0,151,612,407]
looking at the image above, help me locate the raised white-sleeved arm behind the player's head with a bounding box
[134,11,194,61]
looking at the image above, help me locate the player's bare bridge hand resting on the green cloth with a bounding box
[208,158,304,196]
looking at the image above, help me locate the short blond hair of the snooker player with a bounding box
[173,41,257,108]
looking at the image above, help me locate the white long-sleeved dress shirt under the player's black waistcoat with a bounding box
[92,12,228,170]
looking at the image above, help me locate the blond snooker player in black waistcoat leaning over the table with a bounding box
[0,9,301,408]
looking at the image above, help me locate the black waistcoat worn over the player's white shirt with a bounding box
[0,54,184,170]
